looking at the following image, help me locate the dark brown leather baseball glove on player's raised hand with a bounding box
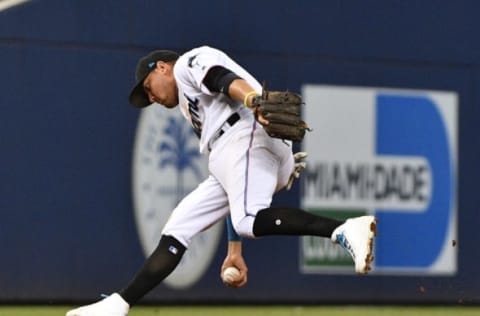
[252,89,310,141]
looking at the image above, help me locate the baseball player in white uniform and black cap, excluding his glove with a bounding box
[67,46,376,316]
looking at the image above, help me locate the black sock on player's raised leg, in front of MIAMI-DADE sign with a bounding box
[253,207,344,238]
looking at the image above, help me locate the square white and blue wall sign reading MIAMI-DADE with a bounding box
[300,85,458,275]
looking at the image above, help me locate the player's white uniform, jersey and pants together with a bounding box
[162,46,294,247]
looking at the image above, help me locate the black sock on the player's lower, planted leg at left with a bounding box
[119,236,186,306]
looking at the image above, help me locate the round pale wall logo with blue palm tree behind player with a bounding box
[132,105,223,289]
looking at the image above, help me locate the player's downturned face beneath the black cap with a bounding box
[143,61,178,108]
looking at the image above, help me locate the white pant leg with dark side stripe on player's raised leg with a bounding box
[209,123,293,237]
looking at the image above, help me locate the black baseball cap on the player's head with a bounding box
[128,50,180,108]
